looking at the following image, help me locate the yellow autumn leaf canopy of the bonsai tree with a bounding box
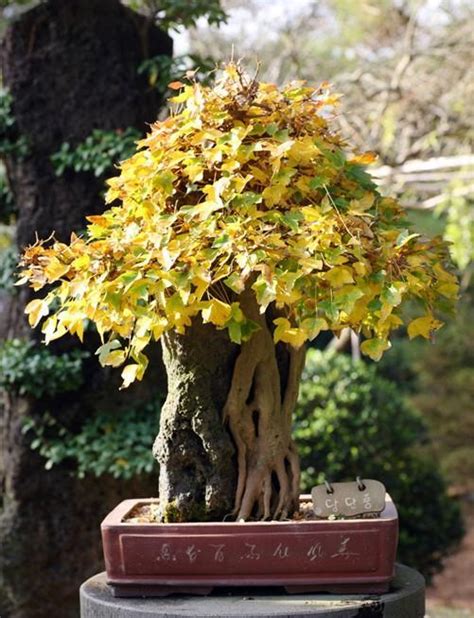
[20,64,457,385]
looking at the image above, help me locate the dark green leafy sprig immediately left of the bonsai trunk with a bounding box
[23,400,161,479]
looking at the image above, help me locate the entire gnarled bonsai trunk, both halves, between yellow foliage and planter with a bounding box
[154,290,304,521]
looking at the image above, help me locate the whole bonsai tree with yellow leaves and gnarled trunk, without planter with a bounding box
[20,64,457,521]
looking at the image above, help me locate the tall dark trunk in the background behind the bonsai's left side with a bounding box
[0,0,172,618]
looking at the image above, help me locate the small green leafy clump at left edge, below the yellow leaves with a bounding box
[0,339,90,399]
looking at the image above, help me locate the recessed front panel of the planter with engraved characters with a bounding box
[121,530,380,577]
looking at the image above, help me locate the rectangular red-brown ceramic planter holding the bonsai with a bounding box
[101,496,398,596]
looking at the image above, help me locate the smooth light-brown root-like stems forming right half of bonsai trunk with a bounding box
[223,290,304,520]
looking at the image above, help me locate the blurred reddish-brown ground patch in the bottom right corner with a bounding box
[427,499,474,618]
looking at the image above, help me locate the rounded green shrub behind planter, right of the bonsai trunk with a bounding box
[295,350,463,578]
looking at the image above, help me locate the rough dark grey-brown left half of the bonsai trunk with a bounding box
[154,320,238,521]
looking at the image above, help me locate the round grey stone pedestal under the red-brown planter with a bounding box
[80,565,425,618]
